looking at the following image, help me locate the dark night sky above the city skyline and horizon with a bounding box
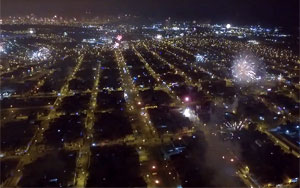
[1,0,299,27]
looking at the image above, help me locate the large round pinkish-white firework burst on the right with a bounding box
[232,56,256,83]
